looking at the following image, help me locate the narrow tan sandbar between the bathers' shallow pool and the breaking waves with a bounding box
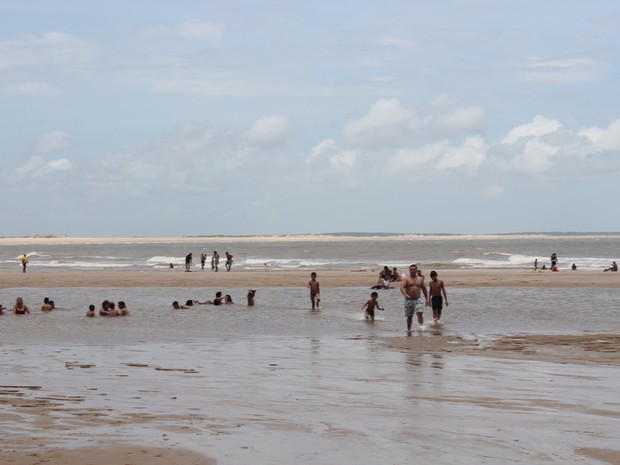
[0,268,620,292]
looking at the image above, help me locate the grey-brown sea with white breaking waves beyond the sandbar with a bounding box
[0,234,620,271]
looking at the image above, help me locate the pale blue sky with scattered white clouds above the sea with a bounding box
[0,0,620,237]
